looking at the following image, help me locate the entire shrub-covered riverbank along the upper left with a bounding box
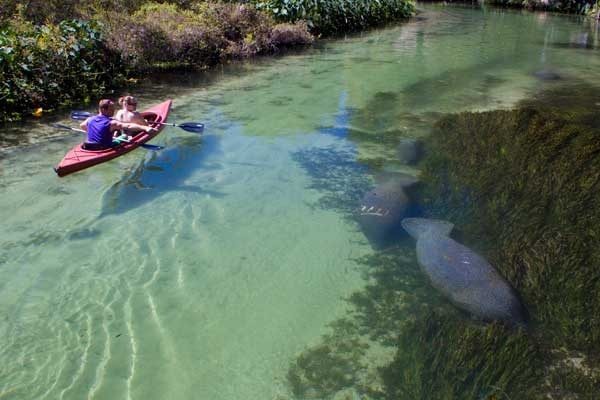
[0,0,414,122]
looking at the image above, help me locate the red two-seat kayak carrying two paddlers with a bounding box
[54,100,172,176]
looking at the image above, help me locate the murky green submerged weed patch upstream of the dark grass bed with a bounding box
[348,52,514,170]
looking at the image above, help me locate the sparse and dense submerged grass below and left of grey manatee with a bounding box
[288,247,544,400]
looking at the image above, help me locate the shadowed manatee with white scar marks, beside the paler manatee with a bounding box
[358,173,418,248]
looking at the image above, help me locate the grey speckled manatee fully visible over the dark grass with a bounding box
[402,218,526,325]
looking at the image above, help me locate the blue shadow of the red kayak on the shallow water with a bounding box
[100,135,225,217]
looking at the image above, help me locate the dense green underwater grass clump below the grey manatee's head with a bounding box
[381,312,544,400]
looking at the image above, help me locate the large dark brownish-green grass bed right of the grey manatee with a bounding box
[414,84,600,396]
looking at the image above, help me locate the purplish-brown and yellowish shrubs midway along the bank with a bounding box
[106,3,313,70]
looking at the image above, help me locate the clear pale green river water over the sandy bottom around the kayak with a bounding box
[0,6,600,400]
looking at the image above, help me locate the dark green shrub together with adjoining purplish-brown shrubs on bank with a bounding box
[0,0,313,121]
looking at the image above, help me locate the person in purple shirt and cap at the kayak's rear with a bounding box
[80,99,156,150]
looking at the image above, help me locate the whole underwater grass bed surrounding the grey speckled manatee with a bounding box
[288,83,600,399]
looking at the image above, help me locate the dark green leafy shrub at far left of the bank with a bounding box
[0,17,121,121]
